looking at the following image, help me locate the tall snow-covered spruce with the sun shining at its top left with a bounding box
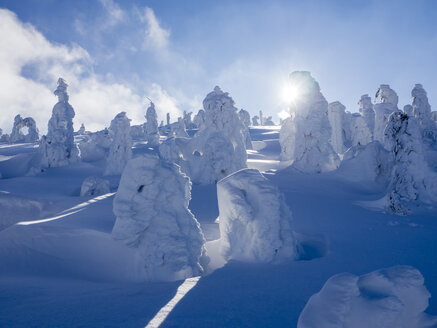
[279,71,340,173]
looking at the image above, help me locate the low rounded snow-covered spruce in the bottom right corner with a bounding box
[297,266,437,328]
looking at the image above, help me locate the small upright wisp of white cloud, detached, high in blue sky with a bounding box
[142,7,170,51]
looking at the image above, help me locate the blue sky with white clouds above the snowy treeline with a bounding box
[0,0,437,132]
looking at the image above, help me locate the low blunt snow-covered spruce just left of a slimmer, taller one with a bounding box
[78,128,112,162]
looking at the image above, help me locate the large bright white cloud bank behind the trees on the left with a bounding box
[0,9,180,133]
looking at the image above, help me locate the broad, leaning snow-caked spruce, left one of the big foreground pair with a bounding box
[112,155,208,281]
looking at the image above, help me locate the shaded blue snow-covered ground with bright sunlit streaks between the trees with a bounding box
[0,127,437,327]
